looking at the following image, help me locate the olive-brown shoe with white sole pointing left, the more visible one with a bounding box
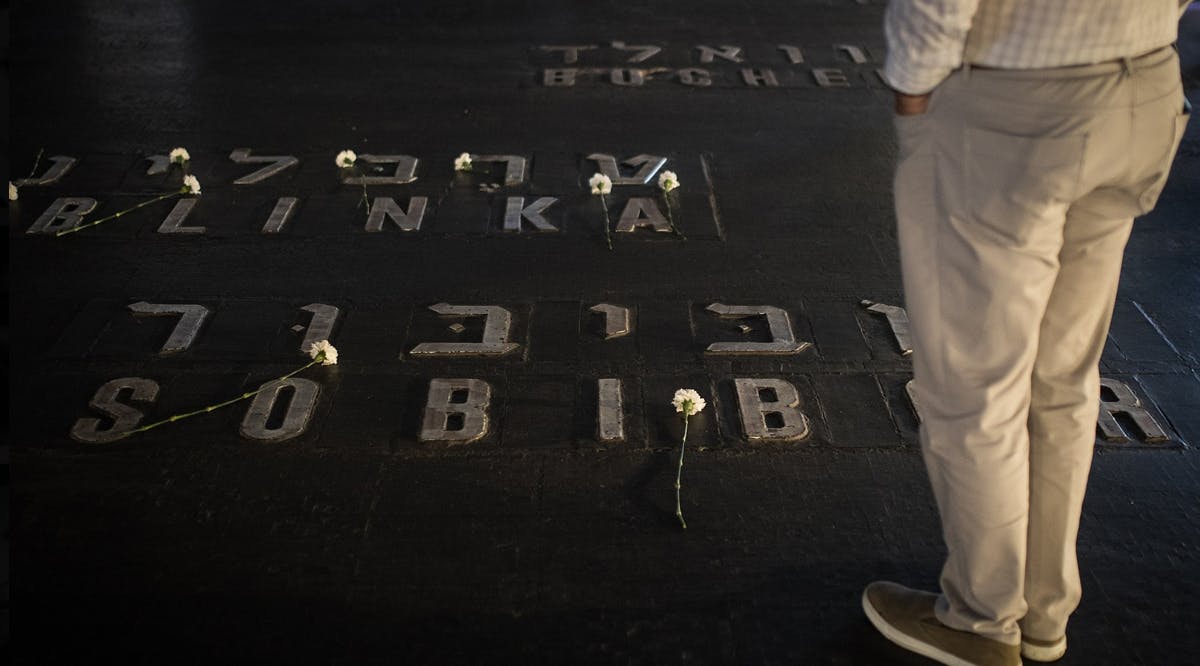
[863,582,1021,666]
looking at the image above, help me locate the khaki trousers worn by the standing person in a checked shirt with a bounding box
[895,48,1187,644]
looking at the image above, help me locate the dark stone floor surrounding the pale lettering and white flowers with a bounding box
[4,0,1200,665]
